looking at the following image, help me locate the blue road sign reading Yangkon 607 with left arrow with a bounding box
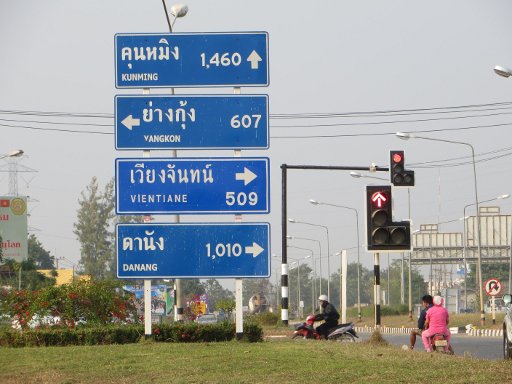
[114,95,269,150]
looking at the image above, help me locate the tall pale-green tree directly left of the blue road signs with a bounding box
[74,177,115,279]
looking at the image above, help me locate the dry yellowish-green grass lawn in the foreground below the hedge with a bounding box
[0,339,512,384]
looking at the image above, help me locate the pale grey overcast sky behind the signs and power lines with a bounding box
[0,0,512,288]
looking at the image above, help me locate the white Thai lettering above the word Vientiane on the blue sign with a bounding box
[130,163,213,184]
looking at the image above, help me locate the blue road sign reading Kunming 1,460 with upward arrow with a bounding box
[115,32,269,88]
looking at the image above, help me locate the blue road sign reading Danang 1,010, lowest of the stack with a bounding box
[117,223,270,279]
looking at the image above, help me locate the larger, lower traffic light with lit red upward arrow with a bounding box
[366,185,411,252]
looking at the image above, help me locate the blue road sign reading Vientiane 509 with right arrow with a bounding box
[116,157,270,214]
